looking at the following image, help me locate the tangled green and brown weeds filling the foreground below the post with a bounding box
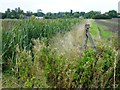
[3,39,116,88]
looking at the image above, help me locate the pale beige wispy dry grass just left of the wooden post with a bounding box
[51,19,91,58]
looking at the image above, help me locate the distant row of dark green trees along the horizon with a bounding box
[1,7,120,19]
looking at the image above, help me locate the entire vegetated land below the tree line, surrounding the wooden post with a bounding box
[2,17,120,88]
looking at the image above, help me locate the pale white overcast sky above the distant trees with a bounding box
[0,0,120,13]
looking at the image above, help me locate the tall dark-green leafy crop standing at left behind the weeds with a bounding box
[2,17,81,68]
